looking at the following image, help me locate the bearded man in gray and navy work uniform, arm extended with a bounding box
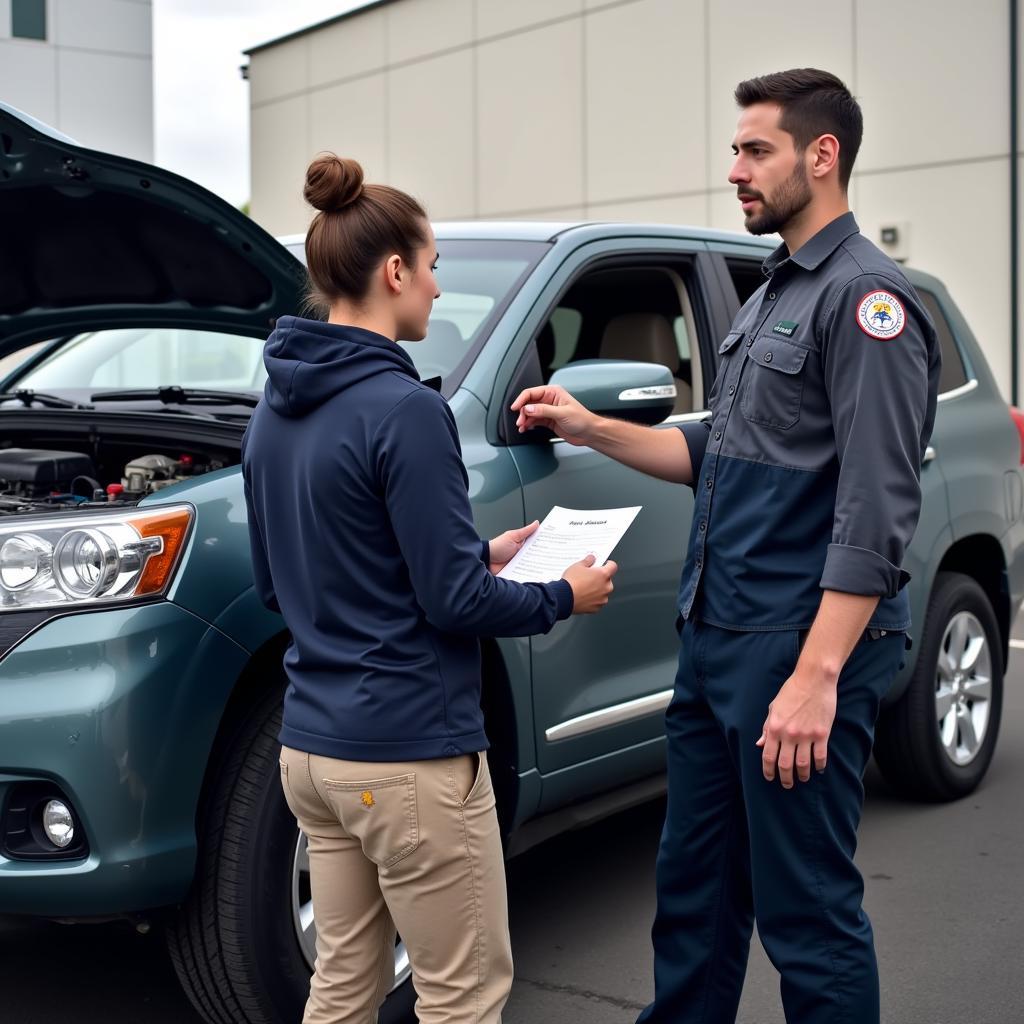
[512,70,940,1024]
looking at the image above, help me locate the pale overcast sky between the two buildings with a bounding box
[153,0,366,206]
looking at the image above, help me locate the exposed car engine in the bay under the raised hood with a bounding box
[0,447,227,515]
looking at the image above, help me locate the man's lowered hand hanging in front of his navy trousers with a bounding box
[758,667,837,790]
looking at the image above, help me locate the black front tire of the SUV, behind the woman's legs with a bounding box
[166,679,415,1024]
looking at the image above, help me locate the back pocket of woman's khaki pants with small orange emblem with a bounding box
[324,774,420,867]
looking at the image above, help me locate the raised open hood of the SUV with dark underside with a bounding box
[0,103,305,356]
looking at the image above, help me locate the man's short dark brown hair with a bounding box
[735,68,864,189]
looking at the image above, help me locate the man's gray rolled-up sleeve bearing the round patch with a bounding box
[821,274,934,597]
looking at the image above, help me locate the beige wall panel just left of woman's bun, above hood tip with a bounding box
[251,96,311,234]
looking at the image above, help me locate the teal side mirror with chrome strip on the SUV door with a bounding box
[550,359,676,425]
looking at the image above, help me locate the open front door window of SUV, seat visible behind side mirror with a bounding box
[536,265,703,415]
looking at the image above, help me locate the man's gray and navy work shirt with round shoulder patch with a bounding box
[679,213,941,630]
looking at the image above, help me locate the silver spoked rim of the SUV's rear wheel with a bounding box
[935,611,992,766]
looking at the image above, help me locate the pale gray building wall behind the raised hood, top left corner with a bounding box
[0,0,153,161]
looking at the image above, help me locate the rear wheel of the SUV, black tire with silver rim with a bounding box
[874,572,1004,801]
